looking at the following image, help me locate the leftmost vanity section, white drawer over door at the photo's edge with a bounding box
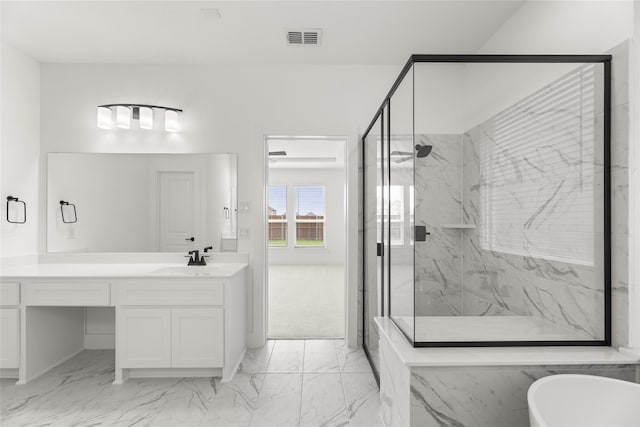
[0,282,20,370]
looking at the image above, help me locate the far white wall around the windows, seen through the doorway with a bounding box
[269,168,346,265]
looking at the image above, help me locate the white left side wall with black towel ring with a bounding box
[0,43,40,256]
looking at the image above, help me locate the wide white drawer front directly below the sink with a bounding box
[117,280,224,306]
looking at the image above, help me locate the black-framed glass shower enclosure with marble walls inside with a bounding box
[362,55,611,372]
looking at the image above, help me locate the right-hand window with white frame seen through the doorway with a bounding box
[294,185,325,247]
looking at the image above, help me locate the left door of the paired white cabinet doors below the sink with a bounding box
[118,308,171,368]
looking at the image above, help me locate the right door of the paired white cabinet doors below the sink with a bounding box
[171,307,224,368]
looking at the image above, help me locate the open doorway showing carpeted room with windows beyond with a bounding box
[265,137,347,339]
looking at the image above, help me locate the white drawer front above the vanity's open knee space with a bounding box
[25,281,110,307]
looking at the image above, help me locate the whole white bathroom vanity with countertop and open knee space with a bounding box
[0,254,248,384]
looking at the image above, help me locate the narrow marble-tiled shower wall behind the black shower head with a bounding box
[415,134,462,316]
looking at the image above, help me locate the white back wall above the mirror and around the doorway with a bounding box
[40,64,400,345]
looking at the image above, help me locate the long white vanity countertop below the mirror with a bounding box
[0,262,248,279]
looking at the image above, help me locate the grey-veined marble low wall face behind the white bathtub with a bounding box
[410,365,636,427]
